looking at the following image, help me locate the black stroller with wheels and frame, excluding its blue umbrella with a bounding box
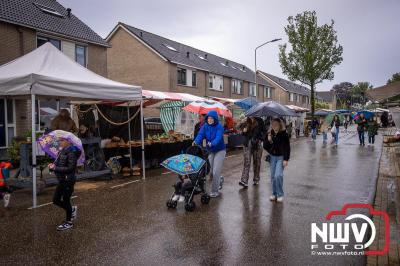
[167,146,210,212]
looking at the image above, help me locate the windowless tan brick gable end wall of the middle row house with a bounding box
[107,28,170,91]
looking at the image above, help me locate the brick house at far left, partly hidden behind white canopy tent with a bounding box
[0,0,109,152]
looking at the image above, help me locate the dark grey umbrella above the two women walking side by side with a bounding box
[246,101,299,117]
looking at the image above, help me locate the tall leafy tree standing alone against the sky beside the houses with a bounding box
[279,11,343,117]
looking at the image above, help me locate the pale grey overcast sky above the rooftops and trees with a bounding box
[59,0,400,90]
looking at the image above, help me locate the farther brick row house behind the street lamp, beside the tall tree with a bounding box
[258,71,314,109]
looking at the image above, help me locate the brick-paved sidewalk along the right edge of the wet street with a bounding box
[367,140,400,265]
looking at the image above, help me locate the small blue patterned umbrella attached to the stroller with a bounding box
[161,154,206,175]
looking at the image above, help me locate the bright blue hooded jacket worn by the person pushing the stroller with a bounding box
[194,111,225,152]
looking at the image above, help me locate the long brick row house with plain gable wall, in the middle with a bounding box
[106,23,286,106]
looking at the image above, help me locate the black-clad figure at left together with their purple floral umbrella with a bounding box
[38,130,85,231]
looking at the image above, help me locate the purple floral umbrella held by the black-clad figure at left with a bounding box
[37,130,85,165]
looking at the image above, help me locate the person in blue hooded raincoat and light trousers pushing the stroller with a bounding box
[193,111,226,198]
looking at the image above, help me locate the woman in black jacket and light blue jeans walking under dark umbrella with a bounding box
[263,118,290,202]
